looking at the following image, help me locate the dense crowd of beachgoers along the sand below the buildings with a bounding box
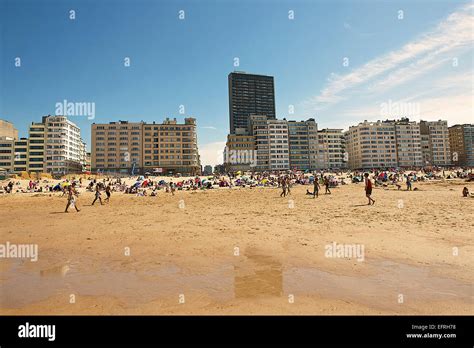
[0,168,474,212]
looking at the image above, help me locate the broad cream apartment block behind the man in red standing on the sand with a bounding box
[345,121,397,169]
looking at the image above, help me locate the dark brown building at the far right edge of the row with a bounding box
[449,124,474,167]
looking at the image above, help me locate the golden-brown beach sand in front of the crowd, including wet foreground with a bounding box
[0,180,474,314]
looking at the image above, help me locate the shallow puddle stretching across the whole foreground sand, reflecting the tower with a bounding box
[0,254,473,309]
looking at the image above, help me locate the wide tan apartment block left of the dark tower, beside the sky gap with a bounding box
[91,118,201,175]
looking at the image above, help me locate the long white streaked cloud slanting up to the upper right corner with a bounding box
[303,3,474,113]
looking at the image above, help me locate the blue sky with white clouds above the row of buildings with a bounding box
[0,0,474,165]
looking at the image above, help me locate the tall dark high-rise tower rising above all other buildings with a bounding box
[228,72,276,134]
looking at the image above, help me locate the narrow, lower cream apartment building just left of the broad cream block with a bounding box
[317,128,347,170]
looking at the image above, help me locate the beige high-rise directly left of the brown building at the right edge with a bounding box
[420,120,451,166]
